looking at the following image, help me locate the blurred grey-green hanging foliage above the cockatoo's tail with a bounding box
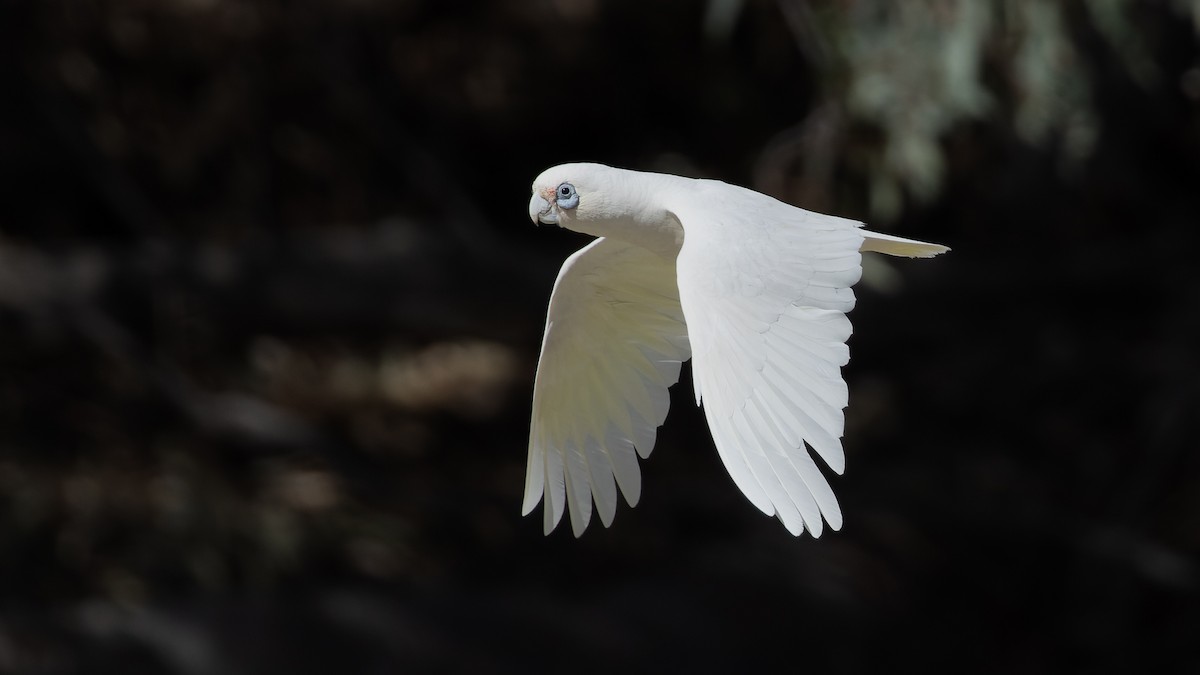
[780,0,1200,221]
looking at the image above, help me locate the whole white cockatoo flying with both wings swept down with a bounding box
[522,163,949,537]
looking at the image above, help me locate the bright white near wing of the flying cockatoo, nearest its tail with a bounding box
[670,181,864,537]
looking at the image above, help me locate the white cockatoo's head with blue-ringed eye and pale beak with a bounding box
[529,163,614,229]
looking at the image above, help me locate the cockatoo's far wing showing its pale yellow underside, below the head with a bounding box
[522,238,690,537]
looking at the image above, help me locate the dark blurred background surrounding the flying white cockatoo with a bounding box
[0,0,1200,675]
